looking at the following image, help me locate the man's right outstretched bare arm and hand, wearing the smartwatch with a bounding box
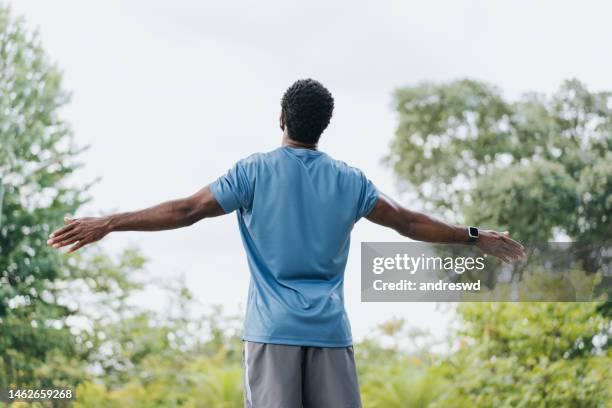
[366,194,524,262]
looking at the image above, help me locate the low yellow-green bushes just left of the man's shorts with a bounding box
[75,294,247,408]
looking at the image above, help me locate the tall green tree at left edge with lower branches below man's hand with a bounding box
[0,6,143,396]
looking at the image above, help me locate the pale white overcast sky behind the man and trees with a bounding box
[9,0,612,339]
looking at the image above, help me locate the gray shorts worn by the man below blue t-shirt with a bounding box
[243,341,361,408]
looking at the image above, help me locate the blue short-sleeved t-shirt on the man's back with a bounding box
[210,146,378,347]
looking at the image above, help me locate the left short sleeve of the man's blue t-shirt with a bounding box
[209,160,253,213]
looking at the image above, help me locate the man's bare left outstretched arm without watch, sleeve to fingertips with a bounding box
[47,187,225,253]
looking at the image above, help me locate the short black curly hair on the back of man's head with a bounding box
[281,79,334,144]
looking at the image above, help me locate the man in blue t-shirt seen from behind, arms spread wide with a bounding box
[49,79,523,408]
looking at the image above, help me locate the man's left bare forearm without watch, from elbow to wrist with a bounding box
[105,199,198,231]
